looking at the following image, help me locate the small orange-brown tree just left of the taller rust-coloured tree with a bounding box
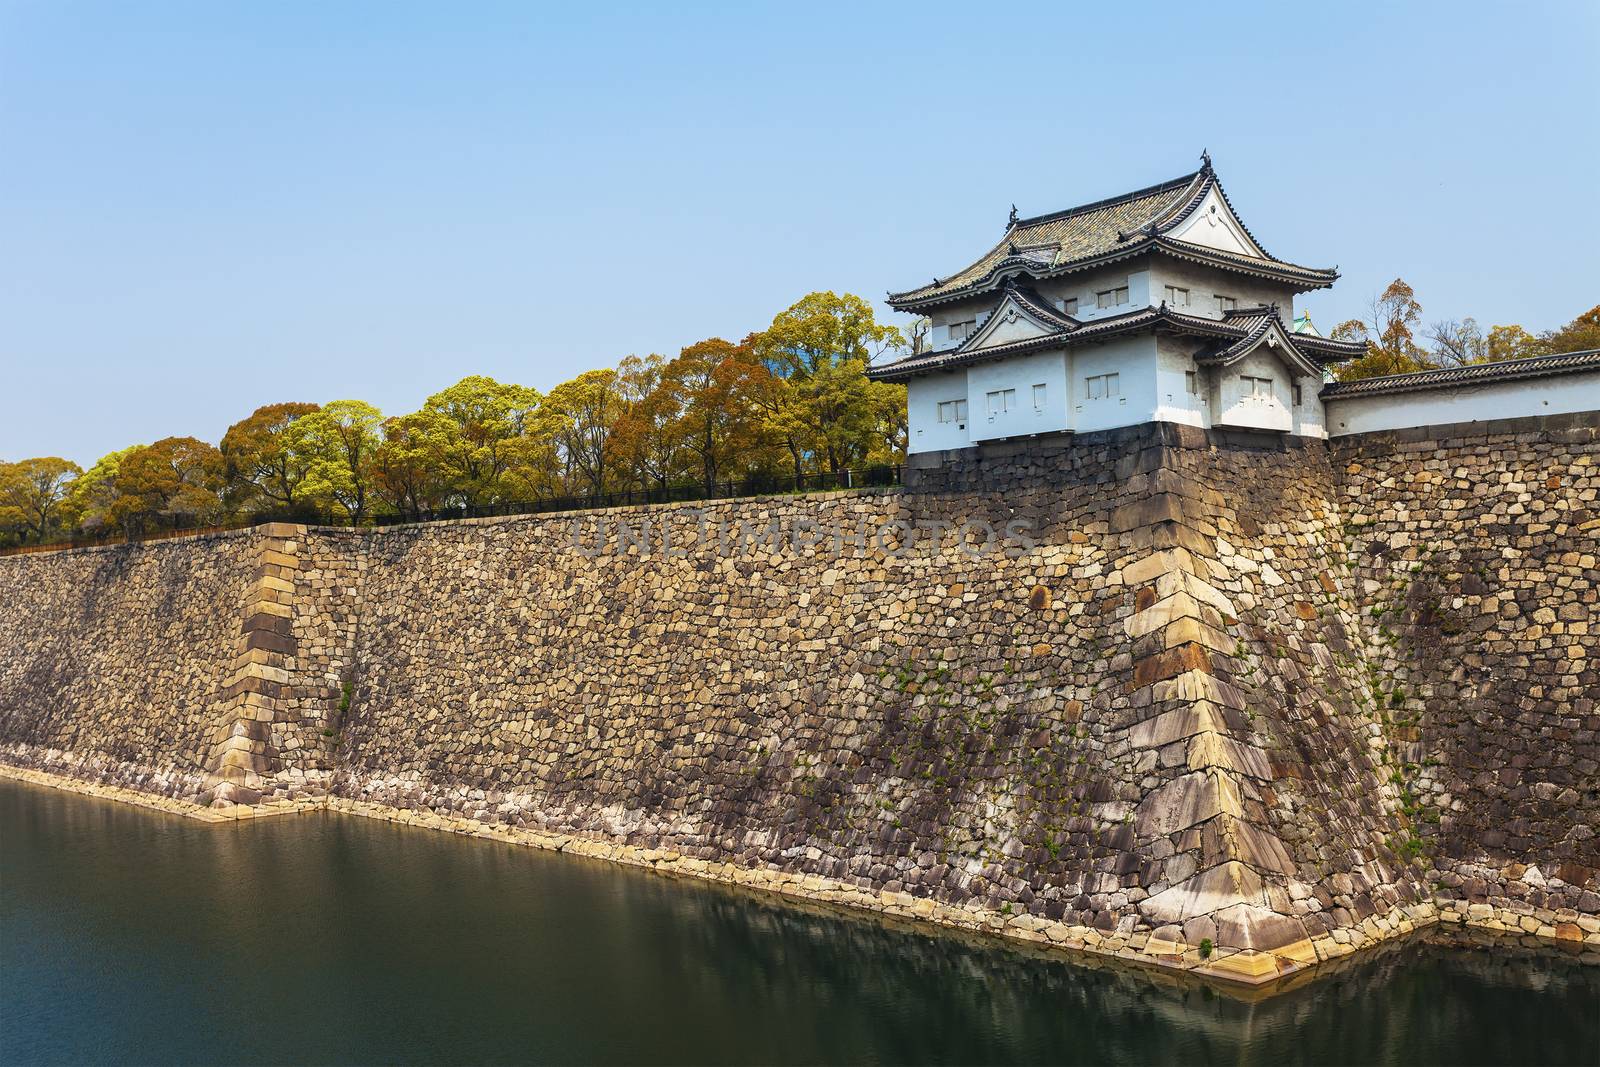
[107,437,226,533]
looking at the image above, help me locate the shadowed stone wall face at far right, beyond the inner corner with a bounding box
[1336,414,1600,921]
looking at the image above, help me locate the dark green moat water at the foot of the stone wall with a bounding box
[0,781,1600,1064]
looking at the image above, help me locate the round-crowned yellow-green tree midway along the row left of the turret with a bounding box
[422,374,539,506]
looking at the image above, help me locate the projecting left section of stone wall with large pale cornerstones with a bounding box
[0,525,340,805]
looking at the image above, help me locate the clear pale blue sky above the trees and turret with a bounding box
[0,0,1600,466]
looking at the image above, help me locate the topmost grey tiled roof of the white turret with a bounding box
[888,160,1338,309]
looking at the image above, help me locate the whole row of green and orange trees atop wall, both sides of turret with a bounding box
[0,286,1600,545]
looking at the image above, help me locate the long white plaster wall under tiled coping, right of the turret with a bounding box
[1326,371,1600,437]
